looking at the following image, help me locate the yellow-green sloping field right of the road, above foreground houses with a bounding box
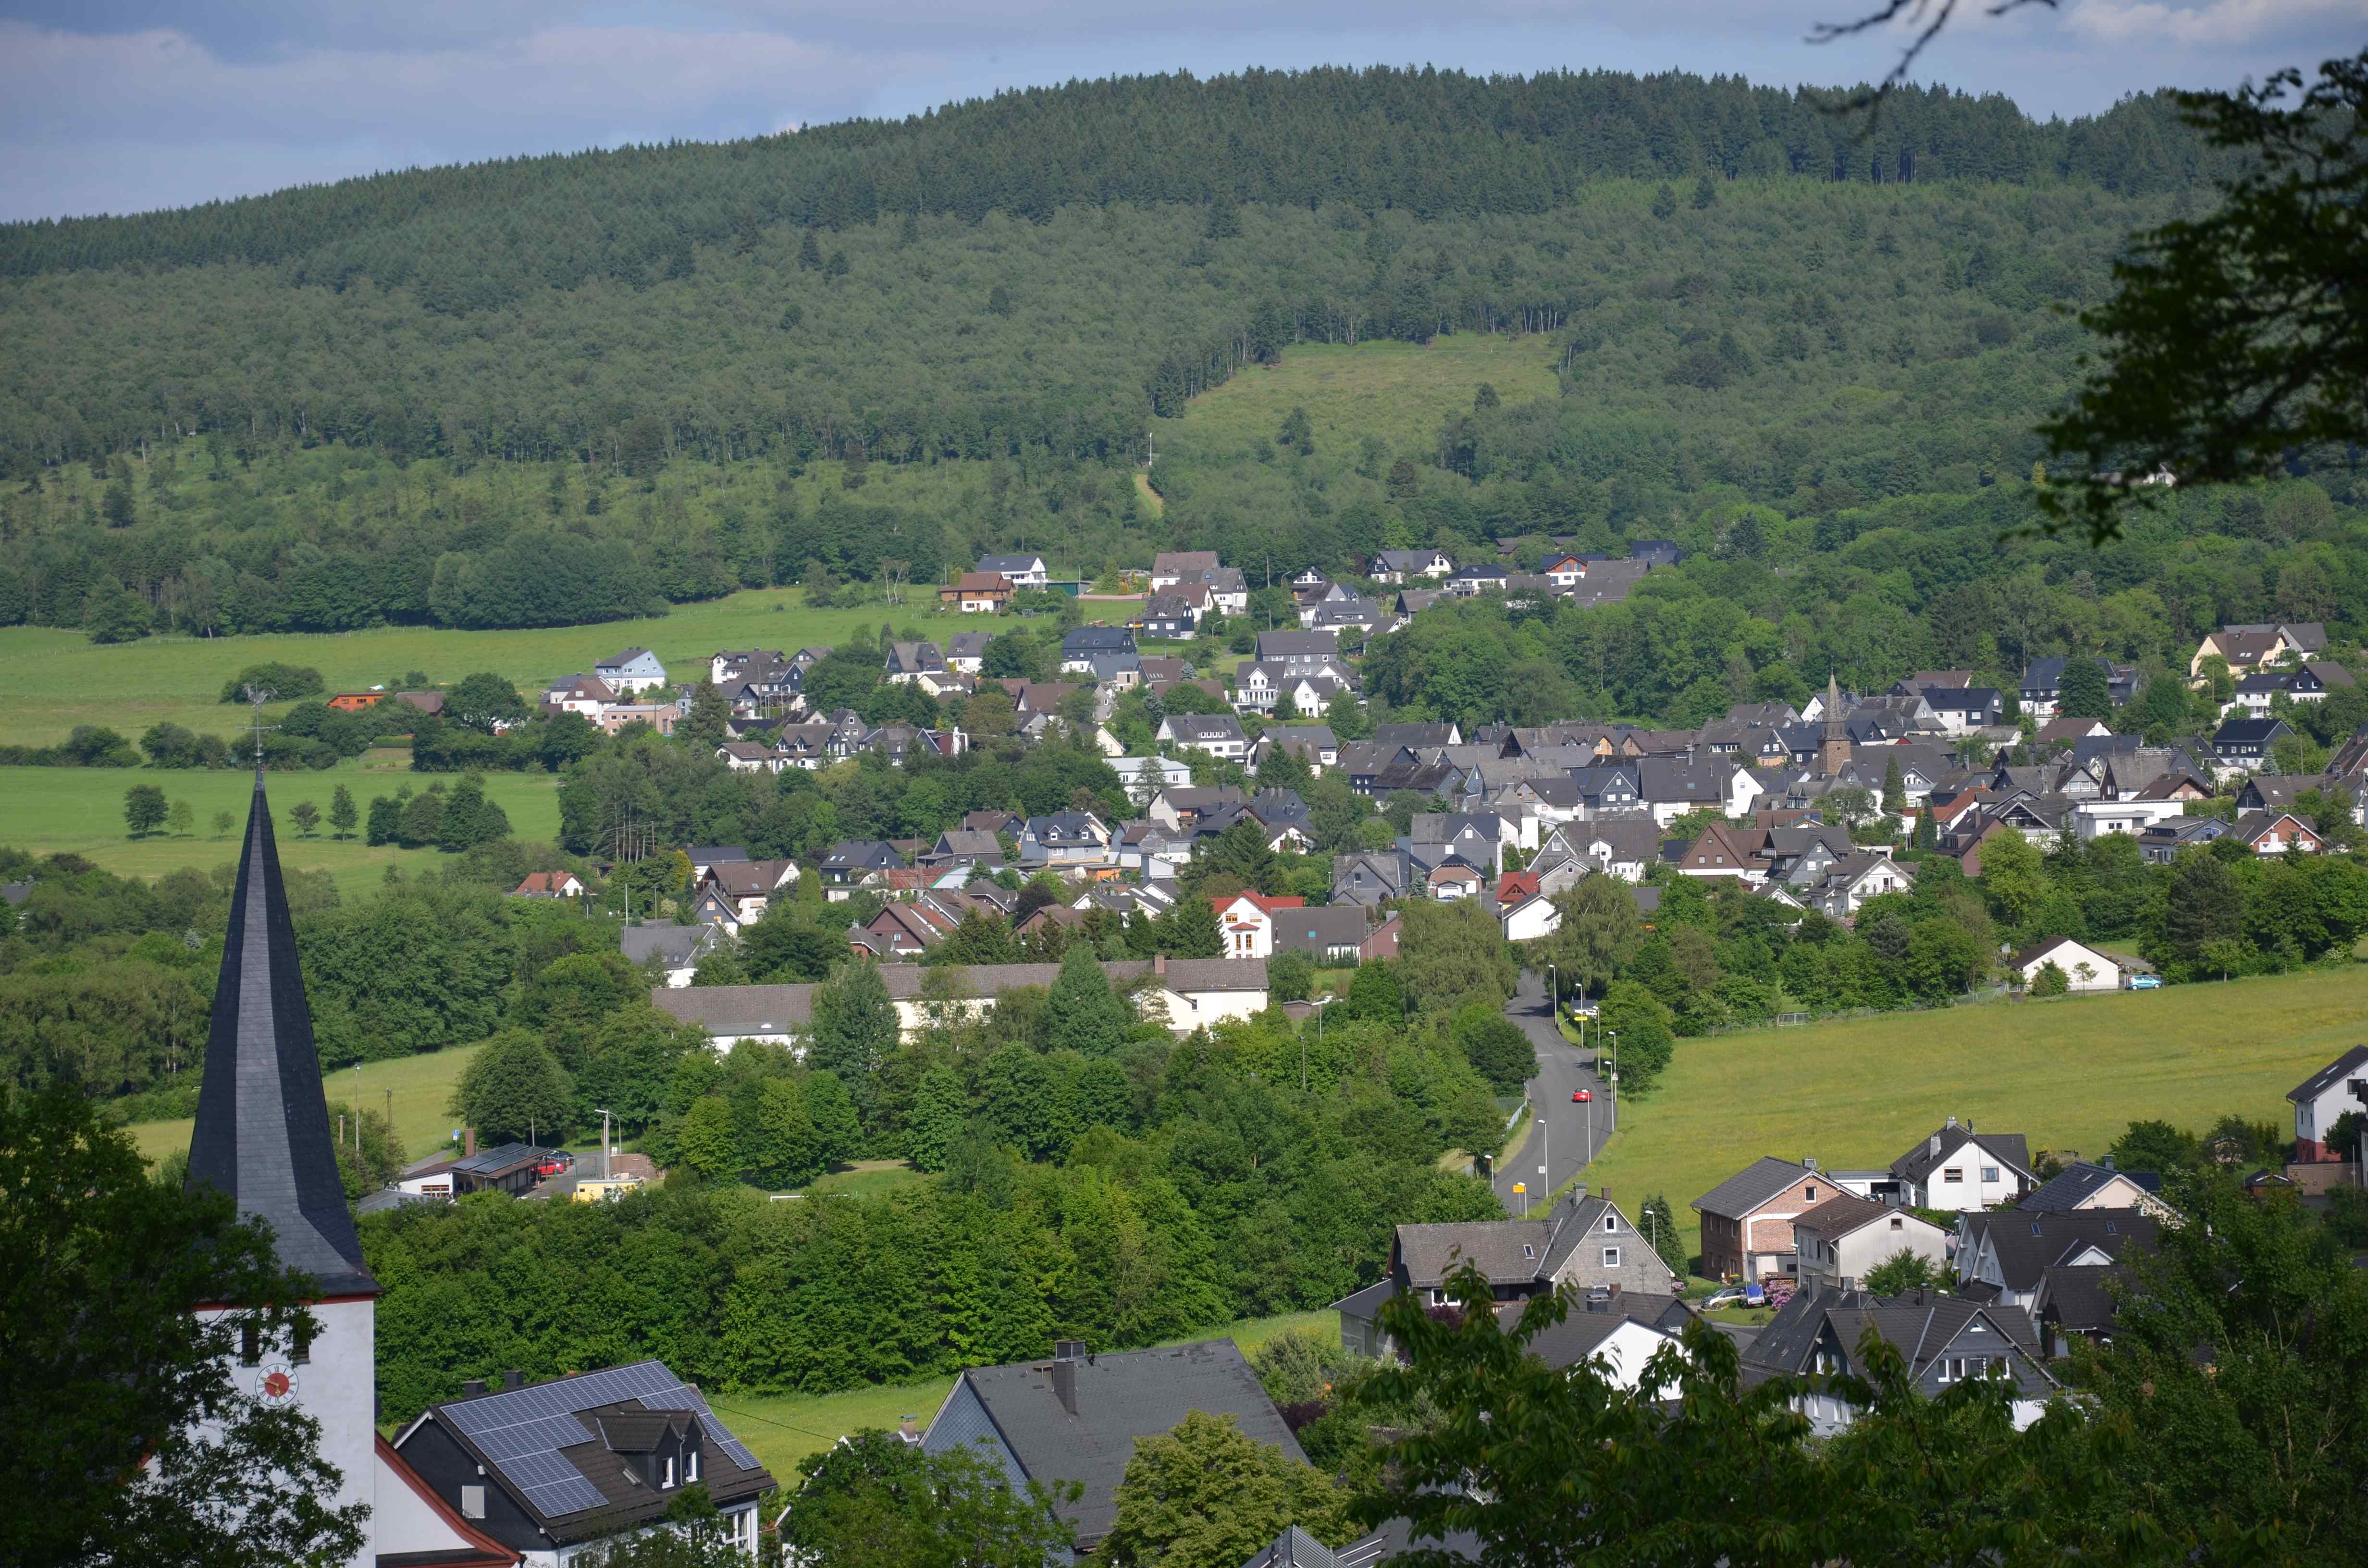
[1589,969,2368,1253]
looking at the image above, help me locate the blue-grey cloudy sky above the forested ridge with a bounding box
[0,0,2368,218]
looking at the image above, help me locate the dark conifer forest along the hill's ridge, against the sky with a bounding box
[0,66,2205,288]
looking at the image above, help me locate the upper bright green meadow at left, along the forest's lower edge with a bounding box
[0,597,1013,758]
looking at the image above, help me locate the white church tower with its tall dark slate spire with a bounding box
[189,767,518,1568]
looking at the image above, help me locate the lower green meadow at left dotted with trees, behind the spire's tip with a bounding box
[0,751,573,898]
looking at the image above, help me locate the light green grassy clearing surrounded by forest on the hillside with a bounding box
[1160,334,1556,460]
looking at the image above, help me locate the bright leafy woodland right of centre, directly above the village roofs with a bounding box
[1364,474,2368,744]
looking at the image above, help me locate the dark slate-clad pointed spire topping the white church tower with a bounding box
[189,767,379,1296]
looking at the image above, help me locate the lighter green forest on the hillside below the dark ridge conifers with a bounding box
[0,169,2245,637]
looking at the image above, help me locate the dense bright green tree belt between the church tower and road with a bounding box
[365,933,1501,1414]
